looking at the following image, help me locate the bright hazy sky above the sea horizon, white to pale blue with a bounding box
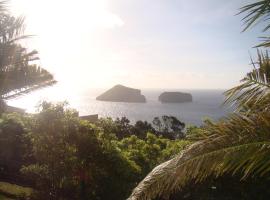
[10,0,261,89]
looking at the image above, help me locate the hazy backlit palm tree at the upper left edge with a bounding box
[0,1,56,109]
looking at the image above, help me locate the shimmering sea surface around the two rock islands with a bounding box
[8,88,232,125]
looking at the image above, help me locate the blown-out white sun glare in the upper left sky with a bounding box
[12,0,124,89]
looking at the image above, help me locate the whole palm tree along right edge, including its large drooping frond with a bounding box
[129,0,270,200]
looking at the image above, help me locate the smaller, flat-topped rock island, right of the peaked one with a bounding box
[158,92,192,103]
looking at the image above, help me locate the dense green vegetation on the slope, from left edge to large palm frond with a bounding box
[0,102,190,199]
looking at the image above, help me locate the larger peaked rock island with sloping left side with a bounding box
[96,85,146,103]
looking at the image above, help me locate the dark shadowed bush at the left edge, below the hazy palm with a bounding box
[0,113,30,181]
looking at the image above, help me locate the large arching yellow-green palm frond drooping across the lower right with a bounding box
[129,112,270,200]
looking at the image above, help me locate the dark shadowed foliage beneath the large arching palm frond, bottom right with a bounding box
[169,174,270,200]
